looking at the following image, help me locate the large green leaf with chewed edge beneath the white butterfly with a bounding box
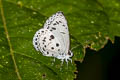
[0,0,120,80]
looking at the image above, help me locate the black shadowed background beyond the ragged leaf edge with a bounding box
[75,37,120,80]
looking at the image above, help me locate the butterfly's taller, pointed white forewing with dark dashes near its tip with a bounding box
[44,12,69,54]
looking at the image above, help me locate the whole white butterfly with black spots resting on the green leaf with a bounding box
[33,11,73,63]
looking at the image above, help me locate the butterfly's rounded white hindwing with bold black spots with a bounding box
[33,29,61,56]
